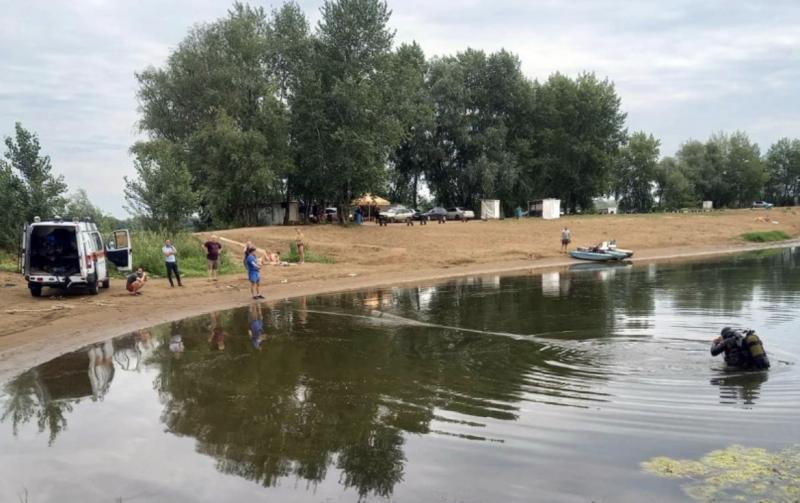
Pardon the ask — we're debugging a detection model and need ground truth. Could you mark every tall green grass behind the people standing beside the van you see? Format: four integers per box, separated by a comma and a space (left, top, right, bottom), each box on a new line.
126, 231, 244, 278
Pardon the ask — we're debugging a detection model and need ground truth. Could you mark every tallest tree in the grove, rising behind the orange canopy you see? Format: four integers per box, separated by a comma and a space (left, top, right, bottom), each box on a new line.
310, 0, 403, 217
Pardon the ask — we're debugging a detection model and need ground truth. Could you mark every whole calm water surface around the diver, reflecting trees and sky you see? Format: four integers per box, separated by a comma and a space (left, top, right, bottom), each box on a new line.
0, 249, 800, 503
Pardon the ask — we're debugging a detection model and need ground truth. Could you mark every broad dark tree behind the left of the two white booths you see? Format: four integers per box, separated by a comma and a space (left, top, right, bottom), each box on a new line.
426, 49, 532, 211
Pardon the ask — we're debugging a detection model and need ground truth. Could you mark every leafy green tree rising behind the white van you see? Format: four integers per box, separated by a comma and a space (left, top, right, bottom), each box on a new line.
5, 122, 67, 221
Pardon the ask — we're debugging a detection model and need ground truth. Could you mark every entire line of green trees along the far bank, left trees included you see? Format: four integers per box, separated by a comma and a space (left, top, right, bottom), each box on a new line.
0, 0, 800, 243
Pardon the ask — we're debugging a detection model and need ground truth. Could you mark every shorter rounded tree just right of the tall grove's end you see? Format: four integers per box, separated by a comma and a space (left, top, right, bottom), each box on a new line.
614, 131, 660, 212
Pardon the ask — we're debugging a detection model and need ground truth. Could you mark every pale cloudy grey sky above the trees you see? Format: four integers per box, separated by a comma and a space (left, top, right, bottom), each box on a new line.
0, 0, 800, 217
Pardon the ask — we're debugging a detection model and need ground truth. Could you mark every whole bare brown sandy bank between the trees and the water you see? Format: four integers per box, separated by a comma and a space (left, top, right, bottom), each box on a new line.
0, 210, 800, 378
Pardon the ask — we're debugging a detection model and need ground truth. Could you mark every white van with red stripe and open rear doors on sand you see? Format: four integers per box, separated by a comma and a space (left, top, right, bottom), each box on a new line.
20, 217, 133, 297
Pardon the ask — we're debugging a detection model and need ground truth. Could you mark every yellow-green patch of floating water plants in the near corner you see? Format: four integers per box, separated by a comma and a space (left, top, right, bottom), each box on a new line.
641, 445, 800, 502
